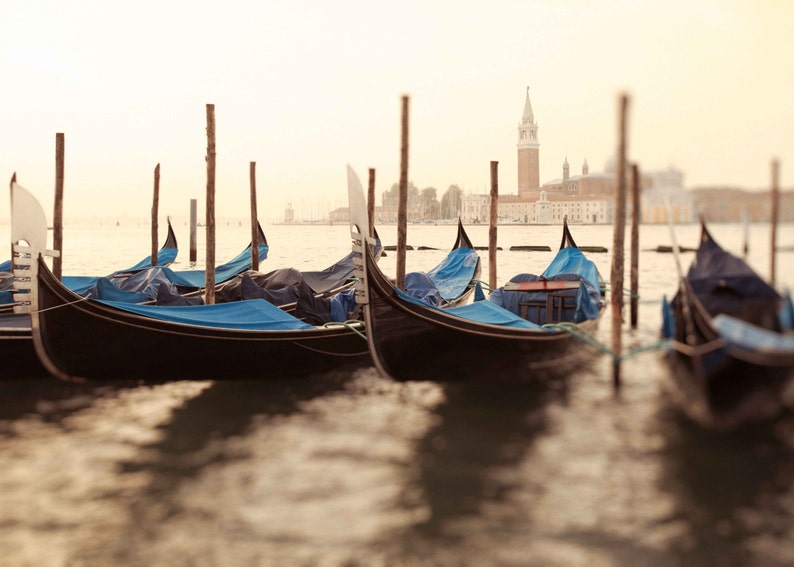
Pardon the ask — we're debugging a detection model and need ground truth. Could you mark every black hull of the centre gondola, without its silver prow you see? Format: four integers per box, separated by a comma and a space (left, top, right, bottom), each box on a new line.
365, 247, 597, 382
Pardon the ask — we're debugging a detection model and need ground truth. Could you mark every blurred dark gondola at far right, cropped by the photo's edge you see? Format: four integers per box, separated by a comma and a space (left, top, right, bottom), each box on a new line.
662, 222, 794, 430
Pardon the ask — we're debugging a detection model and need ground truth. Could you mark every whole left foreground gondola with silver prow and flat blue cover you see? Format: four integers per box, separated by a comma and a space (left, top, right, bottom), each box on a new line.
12, 183, 369, 381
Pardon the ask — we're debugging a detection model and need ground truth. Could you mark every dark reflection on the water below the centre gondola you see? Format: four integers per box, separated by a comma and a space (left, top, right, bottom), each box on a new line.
388, 381, 567, 552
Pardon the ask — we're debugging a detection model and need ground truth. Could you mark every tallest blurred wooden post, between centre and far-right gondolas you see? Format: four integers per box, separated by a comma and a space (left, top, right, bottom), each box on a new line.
610, 94, 629, 387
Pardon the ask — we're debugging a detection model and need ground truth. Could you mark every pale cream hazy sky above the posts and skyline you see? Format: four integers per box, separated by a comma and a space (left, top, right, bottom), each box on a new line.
0, 0, 794, 221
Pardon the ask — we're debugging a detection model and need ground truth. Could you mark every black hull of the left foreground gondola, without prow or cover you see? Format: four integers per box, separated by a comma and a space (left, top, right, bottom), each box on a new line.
33, 259, 369, 380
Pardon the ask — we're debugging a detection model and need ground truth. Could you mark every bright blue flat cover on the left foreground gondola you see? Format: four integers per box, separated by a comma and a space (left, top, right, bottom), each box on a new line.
100, 299, 315, 331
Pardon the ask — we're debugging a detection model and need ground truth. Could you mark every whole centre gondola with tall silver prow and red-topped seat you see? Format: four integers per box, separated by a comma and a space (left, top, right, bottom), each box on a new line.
348, 168, 604, 382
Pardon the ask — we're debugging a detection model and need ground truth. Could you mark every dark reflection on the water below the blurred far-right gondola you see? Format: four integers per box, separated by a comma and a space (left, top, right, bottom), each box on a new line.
659, 406, 794, 566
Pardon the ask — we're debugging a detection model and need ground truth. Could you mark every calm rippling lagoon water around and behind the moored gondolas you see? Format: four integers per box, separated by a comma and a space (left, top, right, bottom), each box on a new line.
0, 223, 794, 566
